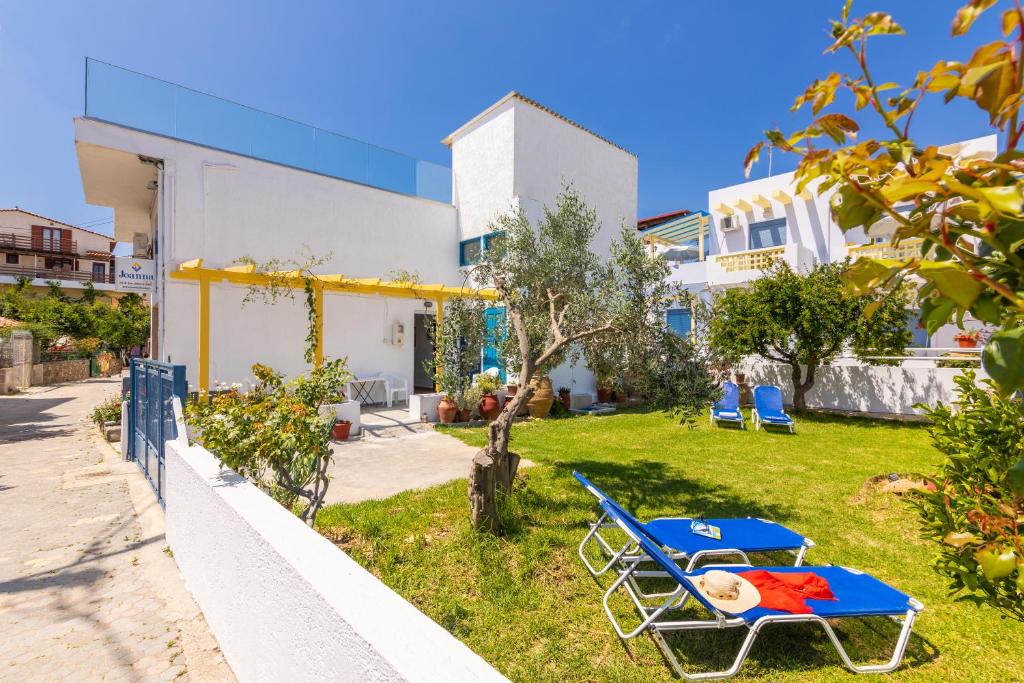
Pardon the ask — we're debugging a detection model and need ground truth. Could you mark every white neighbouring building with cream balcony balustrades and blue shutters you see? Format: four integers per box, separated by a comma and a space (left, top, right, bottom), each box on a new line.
638, 135, 997, 348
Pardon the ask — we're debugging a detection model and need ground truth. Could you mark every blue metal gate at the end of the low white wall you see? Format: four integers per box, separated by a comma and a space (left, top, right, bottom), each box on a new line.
128, 358, 187, 505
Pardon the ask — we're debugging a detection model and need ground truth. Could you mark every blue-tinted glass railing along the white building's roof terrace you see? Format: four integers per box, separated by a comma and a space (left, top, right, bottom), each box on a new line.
85, 59, 452, 204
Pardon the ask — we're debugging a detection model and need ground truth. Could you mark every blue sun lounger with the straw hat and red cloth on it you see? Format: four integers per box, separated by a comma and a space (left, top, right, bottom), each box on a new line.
601, 501, 925, 680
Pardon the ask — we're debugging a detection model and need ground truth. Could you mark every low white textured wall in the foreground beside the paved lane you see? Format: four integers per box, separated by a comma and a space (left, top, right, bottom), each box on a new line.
166, 441, 506, 683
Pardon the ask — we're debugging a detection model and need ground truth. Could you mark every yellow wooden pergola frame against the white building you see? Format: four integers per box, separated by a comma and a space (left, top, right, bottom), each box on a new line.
170, 258, 498, 393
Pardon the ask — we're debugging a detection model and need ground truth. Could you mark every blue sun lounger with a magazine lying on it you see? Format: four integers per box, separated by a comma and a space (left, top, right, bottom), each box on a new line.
572, 472, 814, 581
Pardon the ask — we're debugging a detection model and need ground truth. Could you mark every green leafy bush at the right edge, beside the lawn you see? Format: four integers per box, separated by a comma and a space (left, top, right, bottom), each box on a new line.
914, 371, 1024, 622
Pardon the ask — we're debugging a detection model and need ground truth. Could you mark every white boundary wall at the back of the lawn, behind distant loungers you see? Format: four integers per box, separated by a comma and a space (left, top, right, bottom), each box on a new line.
743, 362, 984, 415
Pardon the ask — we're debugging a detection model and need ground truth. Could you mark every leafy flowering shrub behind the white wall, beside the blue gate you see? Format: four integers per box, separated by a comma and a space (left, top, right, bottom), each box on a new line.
185, 358, 351, 525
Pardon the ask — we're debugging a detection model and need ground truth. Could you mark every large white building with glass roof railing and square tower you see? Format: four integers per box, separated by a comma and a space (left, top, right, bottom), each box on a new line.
75, 60, 637, 392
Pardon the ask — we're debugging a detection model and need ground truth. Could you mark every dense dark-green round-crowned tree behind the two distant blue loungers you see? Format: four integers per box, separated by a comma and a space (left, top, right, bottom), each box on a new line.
708, 261, 911, 410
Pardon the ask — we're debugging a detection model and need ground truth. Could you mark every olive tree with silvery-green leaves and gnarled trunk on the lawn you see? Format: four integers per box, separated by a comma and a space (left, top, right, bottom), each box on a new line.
469, 185, 675, 531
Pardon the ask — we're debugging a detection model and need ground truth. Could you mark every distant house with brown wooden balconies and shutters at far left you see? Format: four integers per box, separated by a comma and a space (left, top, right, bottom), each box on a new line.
0, 207, 117, 292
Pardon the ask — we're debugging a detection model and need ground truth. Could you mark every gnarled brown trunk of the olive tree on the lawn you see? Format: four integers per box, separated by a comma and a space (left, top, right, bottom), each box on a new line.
468, 385, 534, 532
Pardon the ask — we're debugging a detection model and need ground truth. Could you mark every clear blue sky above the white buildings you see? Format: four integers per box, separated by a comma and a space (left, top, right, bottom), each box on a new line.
0, 0, 996, 232
